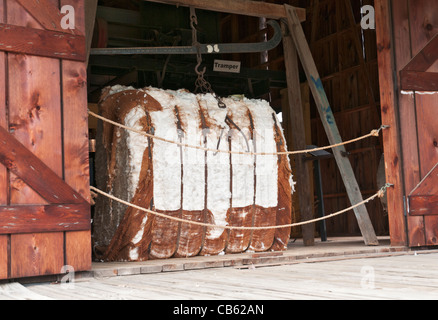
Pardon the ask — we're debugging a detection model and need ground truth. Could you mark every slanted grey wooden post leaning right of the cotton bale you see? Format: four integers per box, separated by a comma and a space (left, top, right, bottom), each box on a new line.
285, 5, 379, 246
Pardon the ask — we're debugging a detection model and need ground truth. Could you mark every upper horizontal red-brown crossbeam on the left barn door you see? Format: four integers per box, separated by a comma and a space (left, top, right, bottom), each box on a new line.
0, 24, 86, 61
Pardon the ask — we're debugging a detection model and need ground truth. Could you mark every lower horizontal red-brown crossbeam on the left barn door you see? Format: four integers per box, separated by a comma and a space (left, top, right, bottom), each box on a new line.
0, 204, 91, 235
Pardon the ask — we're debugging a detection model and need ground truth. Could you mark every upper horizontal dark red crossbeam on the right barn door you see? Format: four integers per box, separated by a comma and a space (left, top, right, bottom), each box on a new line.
400, 70, 438, 91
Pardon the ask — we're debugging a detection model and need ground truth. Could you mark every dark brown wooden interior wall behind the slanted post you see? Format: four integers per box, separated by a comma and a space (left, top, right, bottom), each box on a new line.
222, 0, 388, 236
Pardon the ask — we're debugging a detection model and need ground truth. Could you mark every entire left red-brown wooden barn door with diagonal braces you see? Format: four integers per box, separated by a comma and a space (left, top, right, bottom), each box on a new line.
0, 0, 91, 279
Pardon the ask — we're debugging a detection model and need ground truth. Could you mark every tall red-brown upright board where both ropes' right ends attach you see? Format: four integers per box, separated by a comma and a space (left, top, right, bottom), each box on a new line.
375, 0, 407, 246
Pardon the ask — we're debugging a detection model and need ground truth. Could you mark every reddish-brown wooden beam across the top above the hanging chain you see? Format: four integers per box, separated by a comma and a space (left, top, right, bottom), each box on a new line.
146, 0, 306, 22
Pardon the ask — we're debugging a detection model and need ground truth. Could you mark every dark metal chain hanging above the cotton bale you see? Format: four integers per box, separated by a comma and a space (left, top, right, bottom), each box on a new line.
190, 7, 227, 109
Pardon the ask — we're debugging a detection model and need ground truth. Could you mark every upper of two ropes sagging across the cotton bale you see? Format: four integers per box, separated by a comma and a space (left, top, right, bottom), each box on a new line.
88, 110, 388, 156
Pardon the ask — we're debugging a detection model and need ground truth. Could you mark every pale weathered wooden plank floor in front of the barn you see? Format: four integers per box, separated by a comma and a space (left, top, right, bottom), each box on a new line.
0, 238, 438, 300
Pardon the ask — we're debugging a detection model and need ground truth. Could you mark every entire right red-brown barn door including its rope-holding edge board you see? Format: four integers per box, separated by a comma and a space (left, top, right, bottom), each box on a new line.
376, 0, 438, 247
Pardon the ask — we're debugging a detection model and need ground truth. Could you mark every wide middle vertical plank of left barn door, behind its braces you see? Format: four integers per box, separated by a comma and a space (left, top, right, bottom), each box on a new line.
7, 0, 64, 278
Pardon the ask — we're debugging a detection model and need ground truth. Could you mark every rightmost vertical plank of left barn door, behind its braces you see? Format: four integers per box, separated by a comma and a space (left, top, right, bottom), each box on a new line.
61, 0, 91, 271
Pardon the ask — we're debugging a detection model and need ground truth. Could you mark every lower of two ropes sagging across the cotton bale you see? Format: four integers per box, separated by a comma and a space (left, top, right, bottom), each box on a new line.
90, 183, 392, 230
